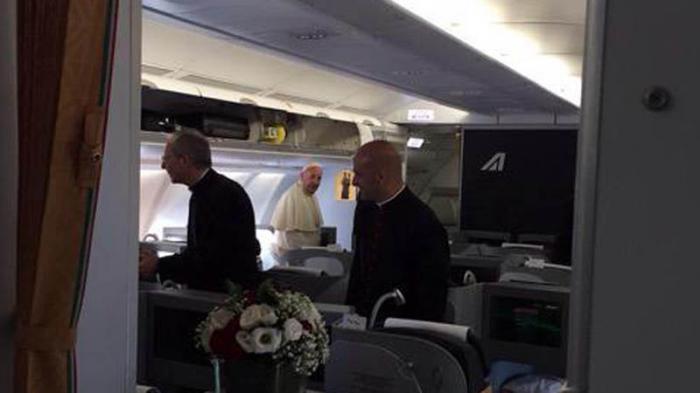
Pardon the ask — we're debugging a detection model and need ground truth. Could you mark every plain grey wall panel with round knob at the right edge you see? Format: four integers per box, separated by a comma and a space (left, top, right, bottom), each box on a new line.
572, 0, 700, 393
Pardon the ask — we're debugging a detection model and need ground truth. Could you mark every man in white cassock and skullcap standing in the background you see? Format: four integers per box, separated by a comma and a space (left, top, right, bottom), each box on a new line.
270, 163, 323, 257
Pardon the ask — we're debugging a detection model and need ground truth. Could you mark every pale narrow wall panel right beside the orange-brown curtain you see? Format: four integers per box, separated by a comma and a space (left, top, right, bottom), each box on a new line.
77, 1, 141, 393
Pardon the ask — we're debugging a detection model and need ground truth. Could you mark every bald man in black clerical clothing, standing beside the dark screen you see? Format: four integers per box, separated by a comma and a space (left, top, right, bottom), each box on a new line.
347, 141, 450, 321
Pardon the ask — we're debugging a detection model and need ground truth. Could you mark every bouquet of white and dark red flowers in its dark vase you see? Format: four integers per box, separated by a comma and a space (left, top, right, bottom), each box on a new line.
195, 280, 329, 393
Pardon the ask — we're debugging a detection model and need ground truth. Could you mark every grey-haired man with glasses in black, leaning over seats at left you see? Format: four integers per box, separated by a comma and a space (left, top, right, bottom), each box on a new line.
139, 131, 260, 291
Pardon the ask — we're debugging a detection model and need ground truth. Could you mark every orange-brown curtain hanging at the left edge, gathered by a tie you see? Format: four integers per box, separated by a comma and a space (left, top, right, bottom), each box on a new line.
14, 0, 117, 393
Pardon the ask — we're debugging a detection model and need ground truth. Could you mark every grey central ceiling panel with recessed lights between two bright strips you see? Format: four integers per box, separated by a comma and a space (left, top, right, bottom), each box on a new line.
144, 0, 577, 113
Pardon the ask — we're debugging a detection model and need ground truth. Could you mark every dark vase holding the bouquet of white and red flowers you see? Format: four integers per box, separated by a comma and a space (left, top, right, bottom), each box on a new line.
223, 358, 306, 393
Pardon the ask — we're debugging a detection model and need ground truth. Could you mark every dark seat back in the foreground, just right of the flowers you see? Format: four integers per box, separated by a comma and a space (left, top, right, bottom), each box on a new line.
325, 319, 486, 393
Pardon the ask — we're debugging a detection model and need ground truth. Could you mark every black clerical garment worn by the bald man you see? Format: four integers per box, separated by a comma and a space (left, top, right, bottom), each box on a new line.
347, 188, 450, 321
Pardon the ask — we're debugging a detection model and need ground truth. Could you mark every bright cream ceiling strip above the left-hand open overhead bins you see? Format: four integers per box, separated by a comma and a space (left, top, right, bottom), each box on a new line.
142, 13, 460, 117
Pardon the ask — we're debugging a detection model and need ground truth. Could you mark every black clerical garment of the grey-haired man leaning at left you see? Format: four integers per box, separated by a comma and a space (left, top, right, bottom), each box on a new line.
158, 169, 260, 291
